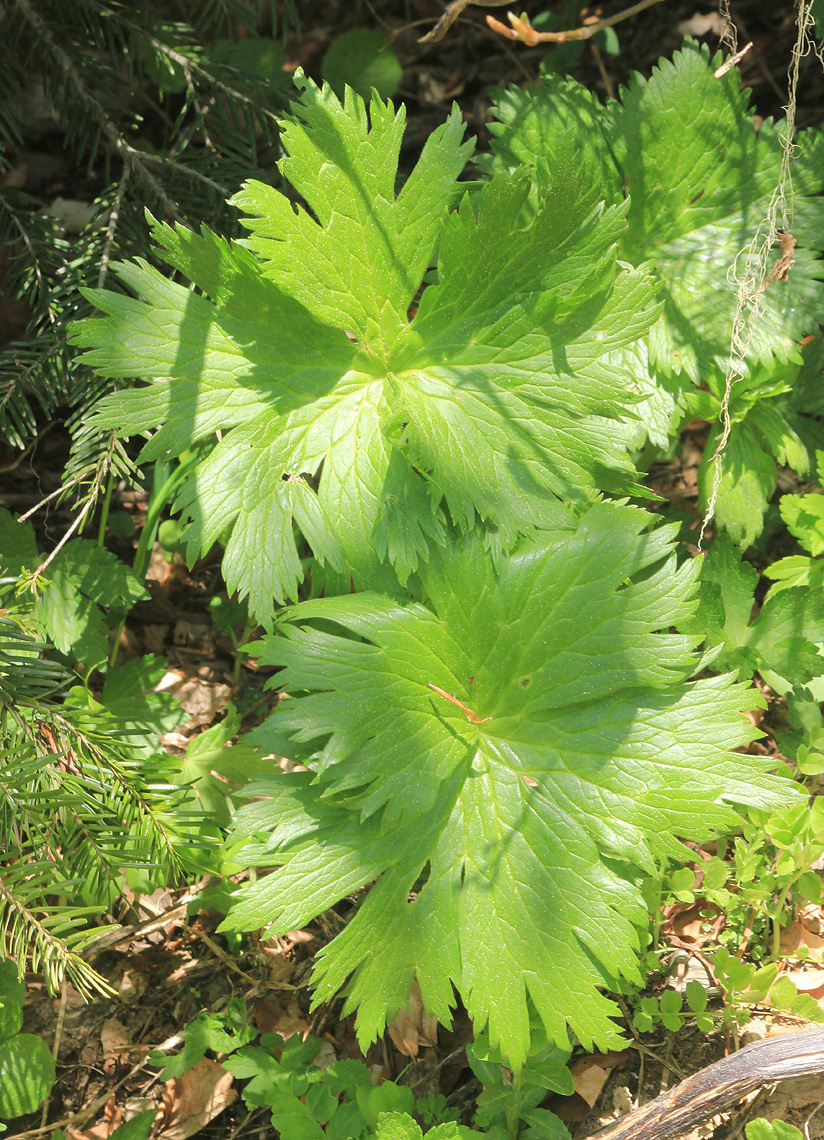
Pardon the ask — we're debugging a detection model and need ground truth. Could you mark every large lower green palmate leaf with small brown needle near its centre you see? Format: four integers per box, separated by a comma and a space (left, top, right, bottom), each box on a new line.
226, 504, 794, 1065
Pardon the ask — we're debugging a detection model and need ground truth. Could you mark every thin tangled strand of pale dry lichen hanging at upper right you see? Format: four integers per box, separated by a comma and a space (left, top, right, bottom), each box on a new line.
699, 0, 814, 551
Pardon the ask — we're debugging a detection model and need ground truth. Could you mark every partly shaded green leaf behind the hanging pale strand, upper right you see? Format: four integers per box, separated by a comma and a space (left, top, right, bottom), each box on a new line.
488, 41, 824, 381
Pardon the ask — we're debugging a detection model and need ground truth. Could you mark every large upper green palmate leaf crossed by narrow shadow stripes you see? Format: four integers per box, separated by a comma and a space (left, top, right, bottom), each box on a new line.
76, 75, 655, 624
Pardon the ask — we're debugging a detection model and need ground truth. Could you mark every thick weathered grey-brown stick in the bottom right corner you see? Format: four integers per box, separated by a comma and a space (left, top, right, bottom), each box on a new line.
589, 1029, 824, 1140
